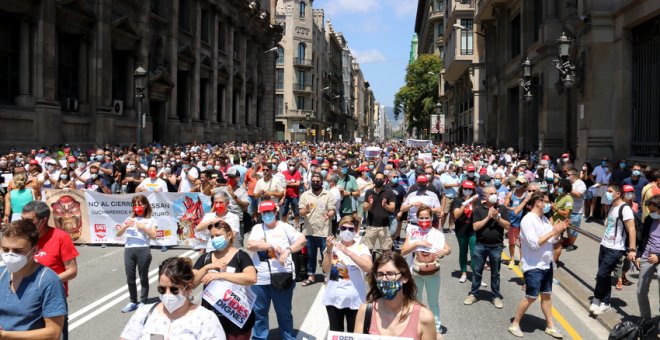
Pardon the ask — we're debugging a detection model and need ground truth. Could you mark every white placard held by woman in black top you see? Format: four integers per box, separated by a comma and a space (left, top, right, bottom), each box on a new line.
202, 280, 257, 328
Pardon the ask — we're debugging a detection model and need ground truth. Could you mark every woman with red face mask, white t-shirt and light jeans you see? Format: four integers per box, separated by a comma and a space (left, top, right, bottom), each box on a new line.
401, 205, 451, 333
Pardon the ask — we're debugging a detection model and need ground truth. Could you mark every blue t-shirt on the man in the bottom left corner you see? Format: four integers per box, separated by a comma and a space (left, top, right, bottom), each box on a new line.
0, 265, 67, 331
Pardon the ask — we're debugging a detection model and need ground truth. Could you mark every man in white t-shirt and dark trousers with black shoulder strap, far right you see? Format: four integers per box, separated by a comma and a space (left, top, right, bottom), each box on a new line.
589, 184, 637, 315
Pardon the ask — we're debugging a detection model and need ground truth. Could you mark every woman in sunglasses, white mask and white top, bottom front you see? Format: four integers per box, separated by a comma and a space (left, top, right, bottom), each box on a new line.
120, 257, 222, 340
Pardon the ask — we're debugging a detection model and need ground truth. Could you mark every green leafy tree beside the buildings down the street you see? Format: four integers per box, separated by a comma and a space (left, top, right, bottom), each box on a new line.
394, 54, 442, 137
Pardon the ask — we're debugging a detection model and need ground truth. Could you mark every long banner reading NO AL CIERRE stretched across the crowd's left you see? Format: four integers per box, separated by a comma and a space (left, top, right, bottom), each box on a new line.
44, 189, 211, 246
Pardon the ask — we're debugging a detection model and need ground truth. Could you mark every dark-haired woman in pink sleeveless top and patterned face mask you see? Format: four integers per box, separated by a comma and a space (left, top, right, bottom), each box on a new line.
354, 251, 436, 340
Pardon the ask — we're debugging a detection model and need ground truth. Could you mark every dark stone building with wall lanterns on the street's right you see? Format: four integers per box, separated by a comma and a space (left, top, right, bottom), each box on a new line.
474, 0, 660, 164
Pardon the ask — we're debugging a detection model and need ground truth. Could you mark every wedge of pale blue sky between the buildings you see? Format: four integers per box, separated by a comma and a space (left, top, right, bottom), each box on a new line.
313, 0, 417, 106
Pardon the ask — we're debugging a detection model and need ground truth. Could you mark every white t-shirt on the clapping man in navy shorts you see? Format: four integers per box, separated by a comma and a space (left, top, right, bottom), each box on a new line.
520, 213, 557, 272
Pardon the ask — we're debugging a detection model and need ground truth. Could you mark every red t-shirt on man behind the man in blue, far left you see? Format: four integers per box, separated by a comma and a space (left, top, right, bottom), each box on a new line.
34, 227, 79, 296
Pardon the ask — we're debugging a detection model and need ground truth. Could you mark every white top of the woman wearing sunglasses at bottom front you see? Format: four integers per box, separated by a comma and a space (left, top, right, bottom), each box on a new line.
121, 304, 222, 340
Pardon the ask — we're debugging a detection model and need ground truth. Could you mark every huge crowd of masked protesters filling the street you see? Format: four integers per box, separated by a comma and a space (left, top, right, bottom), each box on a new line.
0, 142, 660, 339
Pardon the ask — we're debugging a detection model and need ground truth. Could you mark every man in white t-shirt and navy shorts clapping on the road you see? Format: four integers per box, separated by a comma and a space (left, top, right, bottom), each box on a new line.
508, 193, 570, 339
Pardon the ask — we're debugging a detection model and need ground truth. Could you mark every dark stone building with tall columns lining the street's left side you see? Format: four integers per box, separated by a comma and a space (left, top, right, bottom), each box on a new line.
0, 0, 281, 148
